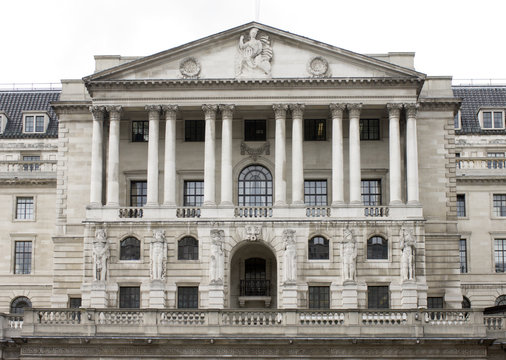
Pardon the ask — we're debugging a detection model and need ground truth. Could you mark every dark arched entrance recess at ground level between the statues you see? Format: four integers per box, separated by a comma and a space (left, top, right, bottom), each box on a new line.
230, 241, 277, 308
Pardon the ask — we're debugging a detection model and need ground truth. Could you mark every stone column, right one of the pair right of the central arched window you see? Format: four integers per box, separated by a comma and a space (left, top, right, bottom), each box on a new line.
290, 104, 305, 205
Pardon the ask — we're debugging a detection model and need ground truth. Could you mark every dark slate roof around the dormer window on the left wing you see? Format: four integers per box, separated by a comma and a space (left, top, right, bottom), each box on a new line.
0, 90, 61, 139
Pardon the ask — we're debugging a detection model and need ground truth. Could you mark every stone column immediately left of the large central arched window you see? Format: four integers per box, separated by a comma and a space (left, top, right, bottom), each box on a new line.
220, 105, 234, 205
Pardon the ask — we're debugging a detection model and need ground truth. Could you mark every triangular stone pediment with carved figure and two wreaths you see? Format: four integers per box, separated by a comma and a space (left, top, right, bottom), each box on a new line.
84, 22, 425, 82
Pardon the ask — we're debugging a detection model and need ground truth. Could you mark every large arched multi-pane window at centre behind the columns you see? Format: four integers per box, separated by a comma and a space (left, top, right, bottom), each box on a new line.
238, 165, 272, 206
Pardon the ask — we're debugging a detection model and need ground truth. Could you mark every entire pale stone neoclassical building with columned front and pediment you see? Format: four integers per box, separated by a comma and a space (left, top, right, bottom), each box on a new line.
0, 23, 506, 359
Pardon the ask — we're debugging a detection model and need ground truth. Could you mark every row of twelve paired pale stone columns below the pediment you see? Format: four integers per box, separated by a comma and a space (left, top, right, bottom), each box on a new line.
90, 103, 419, 207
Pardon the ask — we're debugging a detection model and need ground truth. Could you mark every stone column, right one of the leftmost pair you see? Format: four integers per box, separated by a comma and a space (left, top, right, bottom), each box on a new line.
106, 106, 122, 206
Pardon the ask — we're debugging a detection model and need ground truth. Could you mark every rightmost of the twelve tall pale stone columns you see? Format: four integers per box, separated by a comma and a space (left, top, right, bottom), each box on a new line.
404, 104, 419, 204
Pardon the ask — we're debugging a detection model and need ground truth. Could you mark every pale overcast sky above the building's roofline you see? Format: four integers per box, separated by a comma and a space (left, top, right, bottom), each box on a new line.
0, 0, 506, 83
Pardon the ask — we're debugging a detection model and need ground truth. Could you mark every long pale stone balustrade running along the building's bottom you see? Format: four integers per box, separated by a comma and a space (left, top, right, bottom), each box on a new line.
0, 309, 494, 338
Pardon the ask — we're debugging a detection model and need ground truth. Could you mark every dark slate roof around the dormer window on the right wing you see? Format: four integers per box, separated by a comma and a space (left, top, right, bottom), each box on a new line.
453, 86, 506, 135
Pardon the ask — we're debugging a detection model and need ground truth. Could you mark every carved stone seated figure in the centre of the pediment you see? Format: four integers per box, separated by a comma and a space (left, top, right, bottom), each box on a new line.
236, 28, 272, 77
